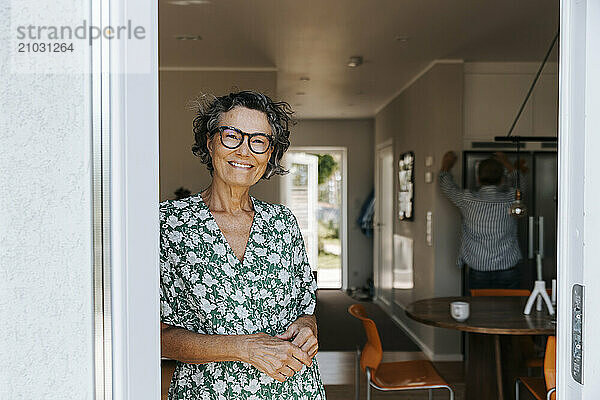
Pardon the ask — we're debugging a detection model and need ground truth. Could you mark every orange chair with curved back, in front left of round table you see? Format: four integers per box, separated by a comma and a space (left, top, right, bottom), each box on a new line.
348, 304, 454, 400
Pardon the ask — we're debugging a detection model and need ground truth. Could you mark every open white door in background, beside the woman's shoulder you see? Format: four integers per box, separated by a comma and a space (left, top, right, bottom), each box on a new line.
281, 152, 319, 271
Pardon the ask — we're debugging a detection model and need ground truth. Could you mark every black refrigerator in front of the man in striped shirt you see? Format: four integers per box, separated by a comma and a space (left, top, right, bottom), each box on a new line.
463, 151, 558, 292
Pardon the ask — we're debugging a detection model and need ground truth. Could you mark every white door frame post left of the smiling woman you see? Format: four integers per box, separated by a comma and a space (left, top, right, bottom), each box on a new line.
96, 0, 161, 400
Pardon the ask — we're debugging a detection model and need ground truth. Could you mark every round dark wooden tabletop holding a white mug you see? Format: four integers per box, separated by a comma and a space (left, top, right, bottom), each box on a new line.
406, 296, 556, 335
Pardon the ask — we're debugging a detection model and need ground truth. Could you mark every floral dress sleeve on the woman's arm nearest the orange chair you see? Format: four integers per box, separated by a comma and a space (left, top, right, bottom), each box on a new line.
286, 208, 317, 317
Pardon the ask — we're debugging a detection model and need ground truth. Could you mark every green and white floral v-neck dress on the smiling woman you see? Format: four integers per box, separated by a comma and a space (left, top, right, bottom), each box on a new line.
160, 193, 325, 400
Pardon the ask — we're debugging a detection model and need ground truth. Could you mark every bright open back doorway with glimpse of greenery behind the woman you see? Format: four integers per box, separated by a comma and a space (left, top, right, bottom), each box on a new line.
280, 147, 347, 289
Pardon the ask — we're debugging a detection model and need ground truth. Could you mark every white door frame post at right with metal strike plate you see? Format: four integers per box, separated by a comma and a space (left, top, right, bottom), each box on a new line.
557, 0, 600, 400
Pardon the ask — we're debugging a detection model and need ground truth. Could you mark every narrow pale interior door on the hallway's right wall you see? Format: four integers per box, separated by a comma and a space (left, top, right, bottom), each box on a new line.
373, 145, 394, 306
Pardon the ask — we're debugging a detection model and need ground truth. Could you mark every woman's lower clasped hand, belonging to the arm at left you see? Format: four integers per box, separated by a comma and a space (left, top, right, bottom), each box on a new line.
240, 333, 312, 382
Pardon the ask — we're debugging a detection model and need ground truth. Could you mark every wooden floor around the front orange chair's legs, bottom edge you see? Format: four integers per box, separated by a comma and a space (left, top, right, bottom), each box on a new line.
162, 351, 465, 400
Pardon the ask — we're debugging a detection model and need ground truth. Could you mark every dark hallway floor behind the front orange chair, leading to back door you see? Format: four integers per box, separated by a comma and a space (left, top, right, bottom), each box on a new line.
315, 290, 420, 351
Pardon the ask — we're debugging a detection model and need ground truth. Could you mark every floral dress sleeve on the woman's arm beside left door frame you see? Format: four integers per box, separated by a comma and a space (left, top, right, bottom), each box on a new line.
159, 202, 183, 327
